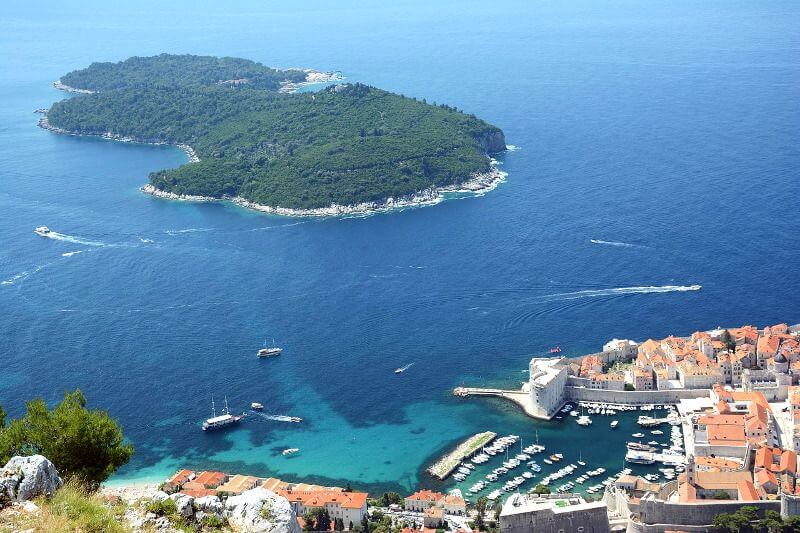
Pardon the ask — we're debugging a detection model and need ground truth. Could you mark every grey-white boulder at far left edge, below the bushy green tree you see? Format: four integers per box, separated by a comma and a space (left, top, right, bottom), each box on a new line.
0, 455, 63, 502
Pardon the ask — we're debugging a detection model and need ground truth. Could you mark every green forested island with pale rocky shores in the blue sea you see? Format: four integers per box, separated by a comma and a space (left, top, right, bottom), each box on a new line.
41, 54, 506, 215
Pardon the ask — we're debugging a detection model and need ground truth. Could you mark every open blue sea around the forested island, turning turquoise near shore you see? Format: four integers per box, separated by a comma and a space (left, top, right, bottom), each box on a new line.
0, 0, 800, 491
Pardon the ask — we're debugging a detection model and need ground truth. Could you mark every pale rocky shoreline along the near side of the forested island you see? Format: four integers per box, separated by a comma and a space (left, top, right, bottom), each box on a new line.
141, 160, 508, 217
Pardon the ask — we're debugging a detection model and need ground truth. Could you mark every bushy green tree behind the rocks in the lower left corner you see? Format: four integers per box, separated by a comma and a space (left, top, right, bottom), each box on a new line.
0, 389, 133, 489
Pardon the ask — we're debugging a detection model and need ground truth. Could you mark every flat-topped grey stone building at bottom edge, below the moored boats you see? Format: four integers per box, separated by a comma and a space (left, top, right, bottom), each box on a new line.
500, 494, 609, 533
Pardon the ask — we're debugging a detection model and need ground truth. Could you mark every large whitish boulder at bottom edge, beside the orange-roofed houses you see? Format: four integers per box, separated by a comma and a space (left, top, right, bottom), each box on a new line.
225, 487, 300, 533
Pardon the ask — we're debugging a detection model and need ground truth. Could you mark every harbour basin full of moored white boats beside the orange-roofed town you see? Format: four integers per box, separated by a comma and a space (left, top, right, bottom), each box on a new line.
432, 402, 684, 502
